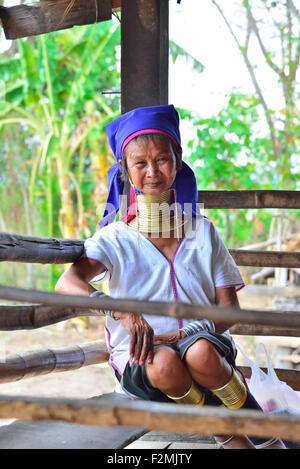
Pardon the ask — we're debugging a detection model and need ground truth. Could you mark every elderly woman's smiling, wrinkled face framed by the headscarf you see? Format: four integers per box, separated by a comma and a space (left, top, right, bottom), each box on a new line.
120, 137, 176, 195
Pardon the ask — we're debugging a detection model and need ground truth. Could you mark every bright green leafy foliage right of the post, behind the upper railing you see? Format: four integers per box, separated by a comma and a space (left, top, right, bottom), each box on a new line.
180, 92, 300, 248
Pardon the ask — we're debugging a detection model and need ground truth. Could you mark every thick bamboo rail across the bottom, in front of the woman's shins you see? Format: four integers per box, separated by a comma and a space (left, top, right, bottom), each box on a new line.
0, 396, 300, 441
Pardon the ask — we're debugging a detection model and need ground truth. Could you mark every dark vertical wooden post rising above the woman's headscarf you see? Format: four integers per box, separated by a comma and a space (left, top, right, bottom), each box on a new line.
121, 0, 169, 113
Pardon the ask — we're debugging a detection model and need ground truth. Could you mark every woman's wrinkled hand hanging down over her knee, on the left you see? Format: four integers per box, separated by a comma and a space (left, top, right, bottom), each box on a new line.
114, 312, 154, 366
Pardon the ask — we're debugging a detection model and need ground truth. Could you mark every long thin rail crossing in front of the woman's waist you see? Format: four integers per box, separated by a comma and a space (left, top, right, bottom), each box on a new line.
0, 286, 300, 329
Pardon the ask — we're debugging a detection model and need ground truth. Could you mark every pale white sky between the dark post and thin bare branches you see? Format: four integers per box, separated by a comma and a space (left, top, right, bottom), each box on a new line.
169, 0, 253, 117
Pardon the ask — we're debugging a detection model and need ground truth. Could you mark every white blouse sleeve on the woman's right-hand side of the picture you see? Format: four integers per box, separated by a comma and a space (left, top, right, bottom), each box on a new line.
211, 223, 245, 291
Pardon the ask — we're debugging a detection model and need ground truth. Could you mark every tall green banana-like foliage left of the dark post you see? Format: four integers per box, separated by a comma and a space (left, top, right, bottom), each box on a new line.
0, 22, 120, 288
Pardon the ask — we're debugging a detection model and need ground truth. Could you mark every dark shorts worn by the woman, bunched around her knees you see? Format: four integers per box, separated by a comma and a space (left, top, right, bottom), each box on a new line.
115, 331, 235, 405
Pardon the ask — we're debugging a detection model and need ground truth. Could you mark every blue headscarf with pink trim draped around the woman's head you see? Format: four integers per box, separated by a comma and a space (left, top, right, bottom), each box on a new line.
98, 104, 199, 228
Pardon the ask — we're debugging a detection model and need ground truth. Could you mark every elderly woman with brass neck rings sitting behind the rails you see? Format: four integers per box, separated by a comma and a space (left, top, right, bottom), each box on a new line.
56, 105, 284, 449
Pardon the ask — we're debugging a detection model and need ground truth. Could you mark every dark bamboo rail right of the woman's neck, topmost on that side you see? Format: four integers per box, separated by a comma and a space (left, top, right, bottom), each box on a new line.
198, 190, 300, 209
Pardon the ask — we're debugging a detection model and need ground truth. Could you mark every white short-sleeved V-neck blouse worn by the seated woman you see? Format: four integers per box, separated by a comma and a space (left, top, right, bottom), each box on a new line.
85, 216, 245, 375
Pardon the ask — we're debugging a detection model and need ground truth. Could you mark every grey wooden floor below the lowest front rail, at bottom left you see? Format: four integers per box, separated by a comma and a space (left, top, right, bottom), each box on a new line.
0, 420, 216, 450
